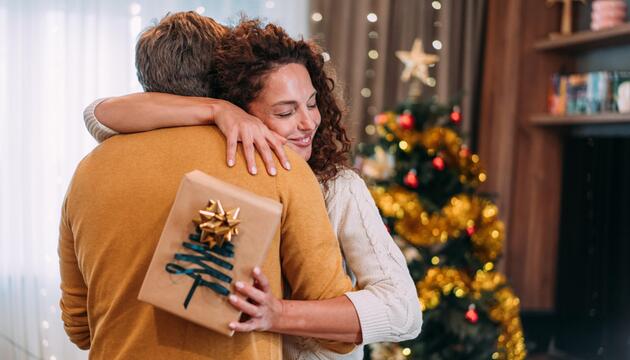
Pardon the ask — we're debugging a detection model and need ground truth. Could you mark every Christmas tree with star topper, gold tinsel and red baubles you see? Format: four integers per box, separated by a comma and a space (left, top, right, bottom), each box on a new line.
357, 40, 526, 360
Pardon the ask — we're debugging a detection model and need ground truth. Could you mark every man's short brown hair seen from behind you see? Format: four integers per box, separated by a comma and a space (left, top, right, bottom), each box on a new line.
136, 11, 228, 96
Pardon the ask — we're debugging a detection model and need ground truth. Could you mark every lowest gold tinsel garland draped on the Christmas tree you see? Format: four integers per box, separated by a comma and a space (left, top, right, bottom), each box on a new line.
417, 267, 527, 360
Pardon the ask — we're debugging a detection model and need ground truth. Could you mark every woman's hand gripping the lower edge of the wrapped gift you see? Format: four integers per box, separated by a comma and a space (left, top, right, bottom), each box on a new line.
228, 267, 283, 332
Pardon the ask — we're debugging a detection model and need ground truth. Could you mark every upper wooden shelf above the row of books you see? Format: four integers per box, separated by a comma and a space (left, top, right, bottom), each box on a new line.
534, 23, 630, 52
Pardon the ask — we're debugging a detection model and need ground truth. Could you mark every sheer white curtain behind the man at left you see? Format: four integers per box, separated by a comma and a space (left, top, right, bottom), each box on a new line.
0, 0, 308, 360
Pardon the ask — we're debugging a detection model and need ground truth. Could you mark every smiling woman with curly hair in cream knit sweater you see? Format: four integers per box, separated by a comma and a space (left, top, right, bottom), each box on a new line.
85, 21, 422, 359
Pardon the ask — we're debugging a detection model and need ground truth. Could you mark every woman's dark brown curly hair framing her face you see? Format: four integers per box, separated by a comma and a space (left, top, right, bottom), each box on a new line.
209, 20, 350, 186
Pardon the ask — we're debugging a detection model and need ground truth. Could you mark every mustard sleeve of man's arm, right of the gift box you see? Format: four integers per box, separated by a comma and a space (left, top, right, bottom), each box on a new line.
276, 152, 356, 354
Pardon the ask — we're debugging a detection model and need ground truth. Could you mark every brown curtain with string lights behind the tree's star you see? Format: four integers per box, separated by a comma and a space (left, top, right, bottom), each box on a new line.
311, 0, 486, 146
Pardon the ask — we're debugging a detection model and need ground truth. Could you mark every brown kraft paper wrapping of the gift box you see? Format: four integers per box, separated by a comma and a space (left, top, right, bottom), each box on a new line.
138, 170, 282, 336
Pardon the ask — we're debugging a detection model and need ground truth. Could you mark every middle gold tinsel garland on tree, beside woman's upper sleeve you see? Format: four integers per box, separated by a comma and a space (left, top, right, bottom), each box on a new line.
370, 186, 505, 262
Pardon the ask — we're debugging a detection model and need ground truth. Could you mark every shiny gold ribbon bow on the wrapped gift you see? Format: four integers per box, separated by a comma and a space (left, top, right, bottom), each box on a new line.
193, 200, 241, 247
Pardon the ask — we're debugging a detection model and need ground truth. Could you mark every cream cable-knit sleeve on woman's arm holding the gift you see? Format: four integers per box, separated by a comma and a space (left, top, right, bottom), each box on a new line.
327, 170, 422, 344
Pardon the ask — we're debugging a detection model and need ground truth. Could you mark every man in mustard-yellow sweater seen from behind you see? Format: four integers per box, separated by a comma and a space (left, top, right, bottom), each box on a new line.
59, 12, 352, 359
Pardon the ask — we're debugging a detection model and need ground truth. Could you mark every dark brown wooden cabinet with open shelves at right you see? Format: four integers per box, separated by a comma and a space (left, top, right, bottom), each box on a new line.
478, 0, 630, 310
